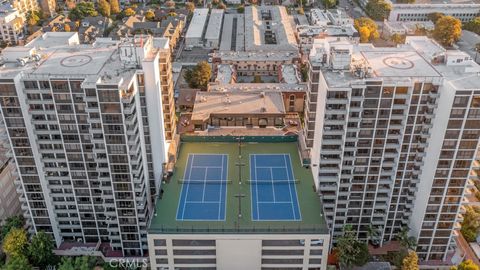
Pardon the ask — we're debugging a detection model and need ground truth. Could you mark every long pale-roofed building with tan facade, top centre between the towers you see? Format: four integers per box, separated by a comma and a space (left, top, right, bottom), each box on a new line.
212, 6, 300, 77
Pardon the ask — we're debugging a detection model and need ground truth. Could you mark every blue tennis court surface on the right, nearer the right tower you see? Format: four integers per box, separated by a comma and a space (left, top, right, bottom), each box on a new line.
250, 154, 302, 221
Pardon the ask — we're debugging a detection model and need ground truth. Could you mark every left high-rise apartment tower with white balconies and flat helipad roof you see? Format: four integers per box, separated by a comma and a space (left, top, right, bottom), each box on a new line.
0, 33, 172, 256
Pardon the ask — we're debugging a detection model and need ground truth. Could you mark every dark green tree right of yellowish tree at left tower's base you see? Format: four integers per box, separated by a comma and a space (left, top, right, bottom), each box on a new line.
28, 231, 55, 268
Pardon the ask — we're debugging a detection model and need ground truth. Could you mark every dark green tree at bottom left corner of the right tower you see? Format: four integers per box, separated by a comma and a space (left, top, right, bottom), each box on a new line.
335, 225, 370, 269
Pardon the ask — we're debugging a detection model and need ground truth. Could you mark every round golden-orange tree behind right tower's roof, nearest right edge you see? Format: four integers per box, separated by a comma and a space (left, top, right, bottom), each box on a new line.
433, 16, 462, 47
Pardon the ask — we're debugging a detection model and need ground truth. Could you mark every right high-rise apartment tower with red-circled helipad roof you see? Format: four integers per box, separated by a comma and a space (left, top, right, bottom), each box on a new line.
304, 37, 480, 260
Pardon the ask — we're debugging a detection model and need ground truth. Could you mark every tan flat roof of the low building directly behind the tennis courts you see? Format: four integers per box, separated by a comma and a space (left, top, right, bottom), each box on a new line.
192, 92, 286, 121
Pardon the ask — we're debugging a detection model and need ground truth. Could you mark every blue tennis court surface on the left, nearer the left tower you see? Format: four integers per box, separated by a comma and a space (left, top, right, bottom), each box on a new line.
177, 154, 228, 220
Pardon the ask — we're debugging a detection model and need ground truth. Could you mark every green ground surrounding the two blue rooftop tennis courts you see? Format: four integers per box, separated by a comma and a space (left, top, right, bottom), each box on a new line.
149, 142, 328, 234
